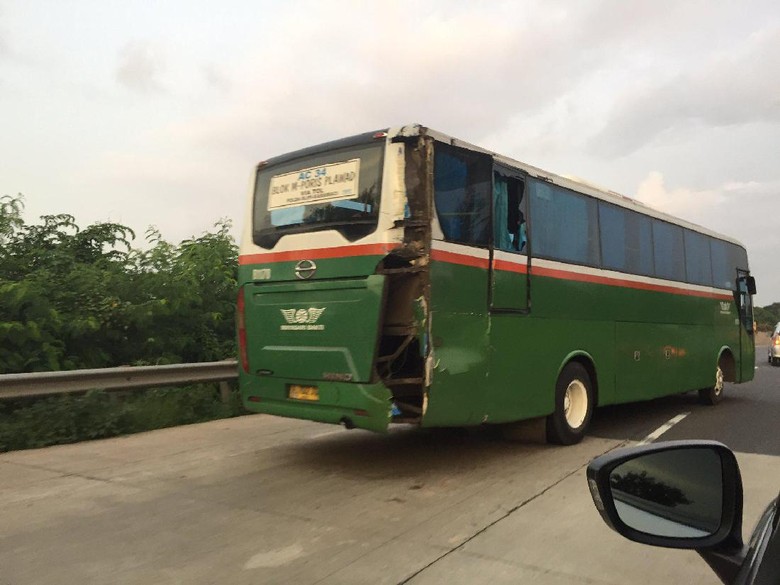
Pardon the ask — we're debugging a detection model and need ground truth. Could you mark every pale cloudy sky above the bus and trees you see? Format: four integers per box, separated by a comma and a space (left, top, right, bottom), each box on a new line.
0, 0, 780, 306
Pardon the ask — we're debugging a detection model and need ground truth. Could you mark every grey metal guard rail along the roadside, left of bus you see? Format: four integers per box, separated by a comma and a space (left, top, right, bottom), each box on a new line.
0, 360, 238, 401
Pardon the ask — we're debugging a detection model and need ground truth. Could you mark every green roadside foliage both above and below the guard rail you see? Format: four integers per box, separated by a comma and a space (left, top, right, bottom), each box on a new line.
0, 195, 242, 452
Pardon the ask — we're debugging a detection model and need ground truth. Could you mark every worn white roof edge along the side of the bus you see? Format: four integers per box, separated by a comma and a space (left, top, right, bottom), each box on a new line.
394, 124, 745, 248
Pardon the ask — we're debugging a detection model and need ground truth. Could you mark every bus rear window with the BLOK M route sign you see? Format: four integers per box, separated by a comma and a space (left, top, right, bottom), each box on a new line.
252, 143, 384, 249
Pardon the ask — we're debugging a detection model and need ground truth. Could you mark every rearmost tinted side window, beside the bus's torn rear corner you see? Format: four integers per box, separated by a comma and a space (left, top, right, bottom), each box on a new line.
433, 142, 491, 246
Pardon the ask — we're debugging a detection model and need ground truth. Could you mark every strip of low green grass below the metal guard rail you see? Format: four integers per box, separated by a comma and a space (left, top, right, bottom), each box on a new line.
0, 384, 246, 452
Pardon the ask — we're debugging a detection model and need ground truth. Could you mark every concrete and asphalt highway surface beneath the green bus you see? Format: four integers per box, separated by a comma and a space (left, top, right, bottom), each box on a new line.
0, 346, 780, 585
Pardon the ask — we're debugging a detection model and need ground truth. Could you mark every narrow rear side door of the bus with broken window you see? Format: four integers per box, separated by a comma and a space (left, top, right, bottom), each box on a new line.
489, 166, 530, 314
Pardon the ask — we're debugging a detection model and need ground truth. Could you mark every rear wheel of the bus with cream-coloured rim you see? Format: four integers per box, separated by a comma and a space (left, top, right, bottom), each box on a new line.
547, 362, 593, 445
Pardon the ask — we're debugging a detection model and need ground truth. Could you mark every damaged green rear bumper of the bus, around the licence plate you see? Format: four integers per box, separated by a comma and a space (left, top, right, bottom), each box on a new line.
241, 376, 392, 433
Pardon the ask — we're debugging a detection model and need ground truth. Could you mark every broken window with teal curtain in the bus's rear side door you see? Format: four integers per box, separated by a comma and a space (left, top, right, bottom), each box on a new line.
493, 173, 528, 252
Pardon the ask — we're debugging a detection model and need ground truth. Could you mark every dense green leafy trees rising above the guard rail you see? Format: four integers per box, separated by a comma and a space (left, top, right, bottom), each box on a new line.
0, 195, 238, 373
